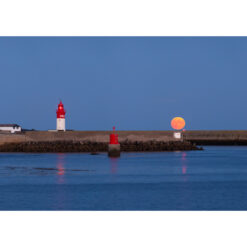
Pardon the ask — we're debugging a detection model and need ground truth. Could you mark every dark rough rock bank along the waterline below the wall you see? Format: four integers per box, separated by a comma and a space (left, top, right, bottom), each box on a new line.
0, 141, 203, 154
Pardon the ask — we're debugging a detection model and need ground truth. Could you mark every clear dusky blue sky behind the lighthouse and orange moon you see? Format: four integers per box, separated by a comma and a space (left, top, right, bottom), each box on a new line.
0, 37, 247, 130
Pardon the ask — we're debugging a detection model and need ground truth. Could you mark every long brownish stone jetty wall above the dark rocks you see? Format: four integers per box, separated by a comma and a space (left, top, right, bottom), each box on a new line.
0, 130, 247, 145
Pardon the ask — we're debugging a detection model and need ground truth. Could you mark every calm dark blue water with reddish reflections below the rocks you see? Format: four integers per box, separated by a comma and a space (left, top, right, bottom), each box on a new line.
0, 147, 247, 210
